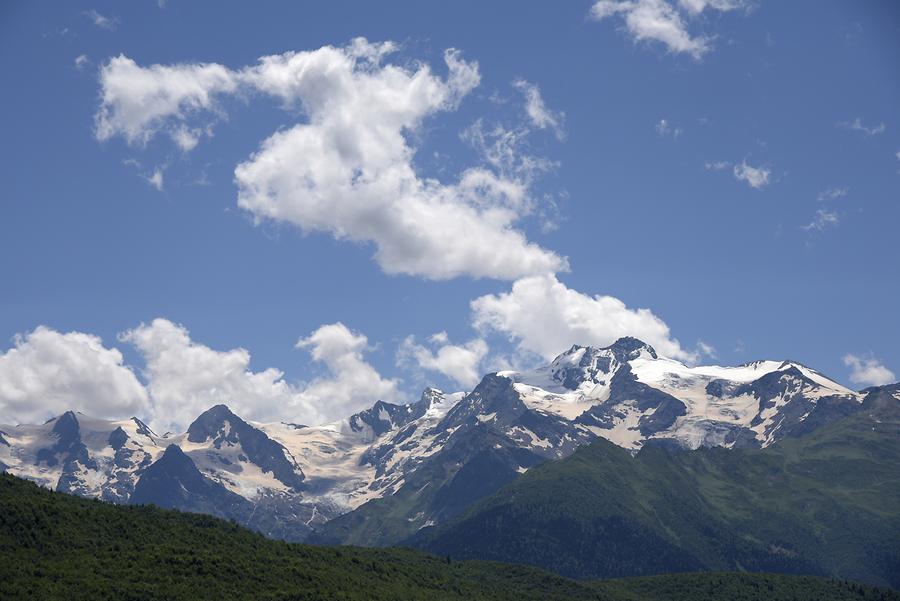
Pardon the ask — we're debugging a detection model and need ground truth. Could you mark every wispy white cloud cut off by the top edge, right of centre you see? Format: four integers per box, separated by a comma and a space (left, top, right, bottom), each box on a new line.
590, 0, 747, 59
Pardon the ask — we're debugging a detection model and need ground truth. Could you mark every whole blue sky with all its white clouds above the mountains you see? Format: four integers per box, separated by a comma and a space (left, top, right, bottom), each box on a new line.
0, 0, 900, 427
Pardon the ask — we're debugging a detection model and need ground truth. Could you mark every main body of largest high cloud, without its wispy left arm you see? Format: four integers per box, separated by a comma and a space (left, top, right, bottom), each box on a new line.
235, 46, 565, 279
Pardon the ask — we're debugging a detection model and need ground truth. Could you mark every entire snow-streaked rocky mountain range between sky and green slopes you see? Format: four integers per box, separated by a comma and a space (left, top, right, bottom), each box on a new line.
0, 338, 862, 543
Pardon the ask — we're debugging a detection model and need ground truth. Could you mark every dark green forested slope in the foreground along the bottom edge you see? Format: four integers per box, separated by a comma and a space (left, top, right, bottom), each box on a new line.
0, 475, 900, 601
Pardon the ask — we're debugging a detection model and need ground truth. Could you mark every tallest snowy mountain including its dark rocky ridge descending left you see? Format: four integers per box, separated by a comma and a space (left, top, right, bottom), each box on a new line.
313, 338, 862, 545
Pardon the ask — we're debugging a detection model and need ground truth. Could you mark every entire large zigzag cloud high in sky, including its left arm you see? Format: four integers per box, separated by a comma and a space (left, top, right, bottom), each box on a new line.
96, 39, 567, 279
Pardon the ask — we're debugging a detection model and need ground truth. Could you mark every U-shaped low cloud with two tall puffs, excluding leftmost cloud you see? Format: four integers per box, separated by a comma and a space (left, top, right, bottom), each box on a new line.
121, 319, 399, 431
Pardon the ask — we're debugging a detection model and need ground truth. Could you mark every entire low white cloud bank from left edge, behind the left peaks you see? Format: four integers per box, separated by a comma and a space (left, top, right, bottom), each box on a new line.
0, 318, 403, 432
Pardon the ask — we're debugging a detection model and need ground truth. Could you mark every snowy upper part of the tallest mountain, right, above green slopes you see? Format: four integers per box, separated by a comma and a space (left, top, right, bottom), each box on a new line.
498, 338, 862, 449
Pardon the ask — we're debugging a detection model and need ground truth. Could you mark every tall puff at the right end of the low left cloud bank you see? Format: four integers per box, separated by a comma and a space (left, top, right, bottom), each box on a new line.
297, 322, 403, 420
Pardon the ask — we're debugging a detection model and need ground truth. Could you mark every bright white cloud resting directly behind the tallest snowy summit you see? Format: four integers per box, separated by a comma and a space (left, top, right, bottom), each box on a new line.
471, 275, 697, 362
